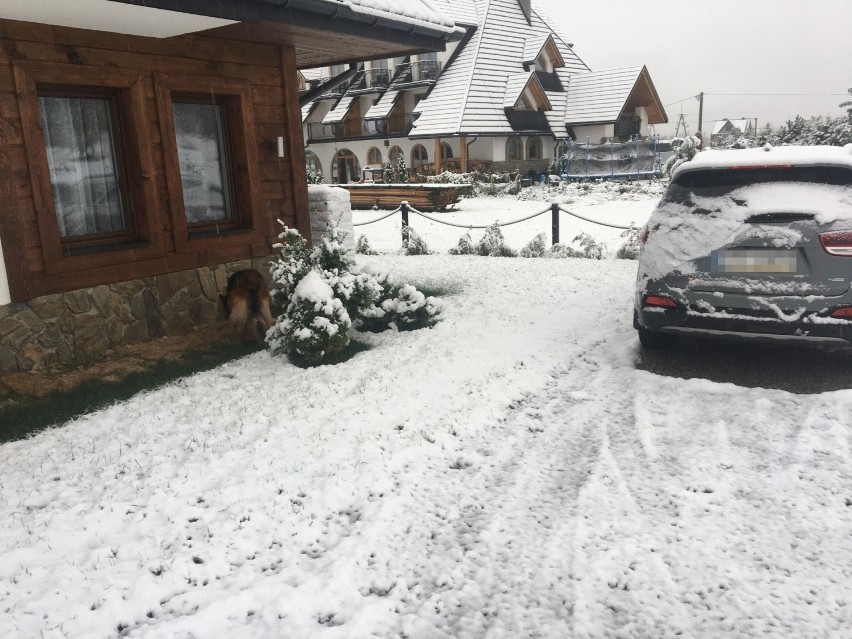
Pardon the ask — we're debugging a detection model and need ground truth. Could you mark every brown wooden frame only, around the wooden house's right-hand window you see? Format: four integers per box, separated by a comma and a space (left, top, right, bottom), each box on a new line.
154, 73, 266, 253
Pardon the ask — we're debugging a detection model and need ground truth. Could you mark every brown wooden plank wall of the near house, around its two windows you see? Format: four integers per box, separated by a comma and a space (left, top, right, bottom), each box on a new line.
0, 20, 310, 301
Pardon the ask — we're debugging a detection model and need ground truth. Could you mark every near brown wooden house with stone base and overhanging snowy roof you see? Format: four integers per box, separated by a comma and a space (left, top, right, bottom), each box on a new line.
0, 0, 458, 372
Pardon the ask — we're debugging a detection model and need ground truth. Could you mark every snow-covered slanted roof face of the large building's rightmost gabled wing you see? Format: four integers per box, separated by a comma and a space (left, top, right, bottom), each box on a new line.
565, 67, 643, 126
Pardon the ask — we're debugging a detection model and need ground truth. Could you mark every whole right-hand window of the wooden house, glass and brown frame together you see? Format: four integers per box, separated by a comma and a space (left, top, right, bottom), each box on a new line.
154, 73, 264, 252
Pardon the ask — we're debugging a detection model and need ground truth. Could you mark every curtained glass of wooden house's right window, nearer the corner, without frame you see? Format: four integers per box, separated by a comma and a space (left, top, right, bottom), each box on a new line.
174, 102, 233, 224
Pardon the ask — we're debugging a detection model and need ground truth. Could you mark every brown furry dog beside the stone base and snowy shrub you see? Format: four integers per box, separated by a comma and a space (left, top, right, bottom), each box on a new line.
219, 269, 273, 343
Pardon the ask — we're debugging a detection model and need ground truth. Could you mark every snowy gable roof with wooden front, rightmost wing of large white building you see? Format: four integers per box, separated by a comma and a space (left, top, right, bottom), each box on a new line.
565, 66, 668, 126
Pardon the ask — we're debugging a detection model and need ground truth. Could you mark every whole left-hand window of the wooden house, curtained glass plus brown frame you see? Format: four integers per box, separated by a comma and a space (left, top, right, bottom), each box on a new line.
12, 61, 164, 278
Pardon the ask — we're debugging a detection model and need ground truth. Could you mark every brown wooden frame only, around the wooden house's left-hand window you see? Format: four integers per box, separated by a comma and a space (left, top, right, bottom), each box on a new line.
13, 62, 164, 274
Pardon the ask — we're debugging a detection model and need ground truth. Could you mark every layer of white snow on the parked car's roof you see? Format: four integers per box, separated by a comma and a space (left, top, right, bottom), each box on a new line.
672, 144, 852, 177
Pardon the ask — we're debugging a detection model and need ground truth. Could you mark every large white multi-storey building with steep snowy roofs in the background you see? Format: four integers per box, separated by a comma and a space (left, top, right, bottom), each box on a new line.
302, 0, 668, 182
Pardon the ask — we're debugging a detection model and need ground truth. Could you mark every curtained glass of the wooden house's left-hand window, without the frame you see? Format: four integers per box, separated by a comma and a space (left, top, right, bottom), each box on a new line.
39, 97, 127, 237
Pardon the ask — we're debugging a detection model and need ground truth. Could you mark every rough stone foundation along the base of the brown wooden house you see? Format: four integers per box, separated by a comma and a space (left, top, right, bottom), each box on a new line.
0, 255, 272, 374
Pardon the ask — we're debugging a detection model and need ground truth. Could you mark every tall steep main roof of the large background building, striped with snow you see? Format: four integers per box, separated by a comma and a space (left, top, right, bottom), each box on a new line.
411, 0, 589, 137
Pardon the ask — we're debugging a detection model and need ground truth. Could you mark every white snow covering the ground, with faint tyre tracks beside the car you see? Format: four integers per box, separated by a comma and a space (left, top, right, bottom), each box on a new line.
0, 190, 852, 639
